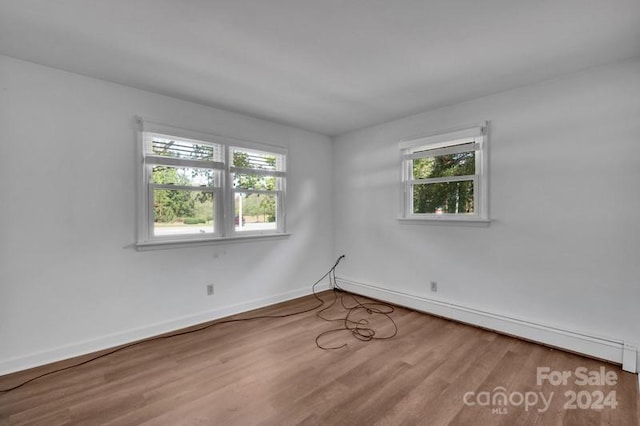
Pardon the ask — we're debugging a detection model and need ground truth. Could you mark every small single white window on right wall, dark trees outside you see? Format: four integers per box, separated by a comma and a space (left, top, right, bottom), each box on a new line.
399, 123, 489, 222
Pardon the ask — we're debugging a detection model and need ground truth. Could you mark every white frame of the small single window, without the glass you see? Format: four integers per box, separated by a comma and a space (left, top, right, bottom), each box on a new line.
398, 122, 490, 224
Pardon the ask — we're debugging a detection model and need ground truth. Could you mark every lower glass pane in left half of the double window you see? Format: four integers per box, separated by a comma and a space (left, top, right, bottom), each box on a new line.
153, 189, 215, 236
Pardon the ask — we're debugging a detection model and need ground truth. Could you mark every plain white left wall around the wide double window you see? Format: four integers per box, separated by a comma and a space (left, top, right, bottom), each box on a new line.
0, 56, 332, 374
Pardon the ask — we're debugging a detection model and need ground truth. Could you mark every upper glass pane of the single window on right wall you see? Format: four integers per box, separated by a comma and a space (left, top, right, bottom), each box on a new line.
413, 151, 476, 179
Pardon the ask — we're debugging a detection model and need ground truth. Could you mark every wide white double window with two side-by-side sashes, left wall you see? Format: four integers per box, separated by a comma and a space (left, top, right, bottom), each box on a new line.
137, 119, 287, 248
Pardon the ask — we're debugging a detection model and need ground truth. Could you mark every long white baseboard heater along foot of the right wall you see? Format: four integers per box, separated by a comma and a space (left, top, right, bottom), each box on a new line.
336, 278, 638, 373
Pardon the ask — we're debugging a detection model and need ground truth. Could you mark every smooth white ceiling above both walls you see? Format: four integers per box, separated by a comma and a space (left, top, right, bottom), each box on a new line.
0, 0, 640, 136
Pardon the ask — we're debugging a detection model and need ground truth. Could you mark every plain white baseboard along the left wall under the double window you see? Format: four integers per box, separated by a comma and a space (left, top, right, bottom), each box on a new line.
0, 285, 328, 375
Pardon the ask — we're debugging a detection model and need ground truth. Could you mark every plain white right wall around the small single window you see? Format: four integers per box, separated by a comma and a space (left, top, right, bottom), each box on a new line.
333, 59, 640, 362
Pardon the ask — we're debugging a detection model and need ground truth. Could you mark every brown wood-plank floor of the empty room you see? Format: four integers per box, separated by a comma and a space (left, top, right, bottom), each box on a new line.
0, 292, 639, 426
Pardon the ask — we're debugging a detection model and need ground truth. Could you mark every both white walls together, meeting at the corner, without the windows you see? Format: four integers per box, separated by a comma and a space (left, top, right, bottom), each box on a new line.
0, 56, 640, 374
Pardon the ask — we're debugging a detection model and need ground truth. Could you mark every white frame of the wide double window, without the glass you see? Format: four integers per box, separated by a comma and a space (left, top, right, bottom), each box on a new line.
136, 117, 289, 250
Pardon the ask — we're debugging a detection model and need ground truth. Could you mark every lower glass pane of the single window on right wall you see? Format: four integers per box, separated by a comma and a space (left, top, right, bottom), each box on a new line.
413, 181, 474, 214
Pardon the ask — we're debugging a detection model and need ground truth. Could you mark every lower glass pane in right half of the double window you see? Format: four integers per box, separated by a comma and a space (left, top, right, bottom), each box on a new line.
235, 192, 277, 231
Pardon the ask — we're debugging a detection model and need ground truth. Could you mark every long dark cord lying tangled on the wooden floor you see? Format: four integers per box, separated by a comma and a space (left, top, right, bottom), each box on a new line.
0, 255, 397, 393
